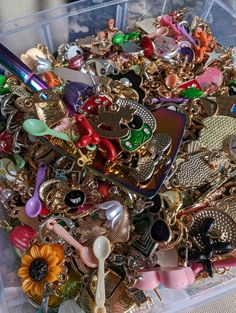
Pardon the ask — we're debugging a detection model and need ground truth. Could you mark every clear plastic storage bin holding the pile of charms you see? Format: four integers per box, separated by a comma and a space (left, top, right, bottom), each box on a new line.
0, 0, 236, 313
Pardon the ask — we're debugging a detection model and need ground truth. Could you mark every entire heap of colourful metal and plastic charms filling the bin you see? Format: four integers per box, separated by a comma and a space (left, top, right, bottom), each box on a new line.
0, 10, 236, 313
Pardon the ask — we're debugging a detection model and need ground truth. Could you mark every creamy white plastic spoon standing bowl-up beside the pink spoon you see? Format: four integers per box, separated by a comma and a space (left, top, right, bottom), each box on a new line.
93, 236, 111, 313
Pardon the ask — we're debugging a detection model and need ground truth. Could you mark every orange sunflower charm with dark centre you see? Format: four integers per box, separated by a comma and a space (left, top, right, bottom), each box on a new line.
18, 244, 64, 297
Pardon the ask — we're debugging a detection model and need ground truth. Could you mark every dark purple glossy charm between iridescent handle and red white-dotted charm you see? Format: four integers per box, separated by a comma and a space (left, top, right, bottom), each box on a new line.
65, 82, 94, 116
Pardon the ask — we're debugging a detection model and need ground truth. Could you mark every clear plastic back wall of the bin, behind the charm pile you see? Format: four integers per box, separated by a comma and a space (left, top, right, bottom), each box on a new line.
0, 0, 236, 55
